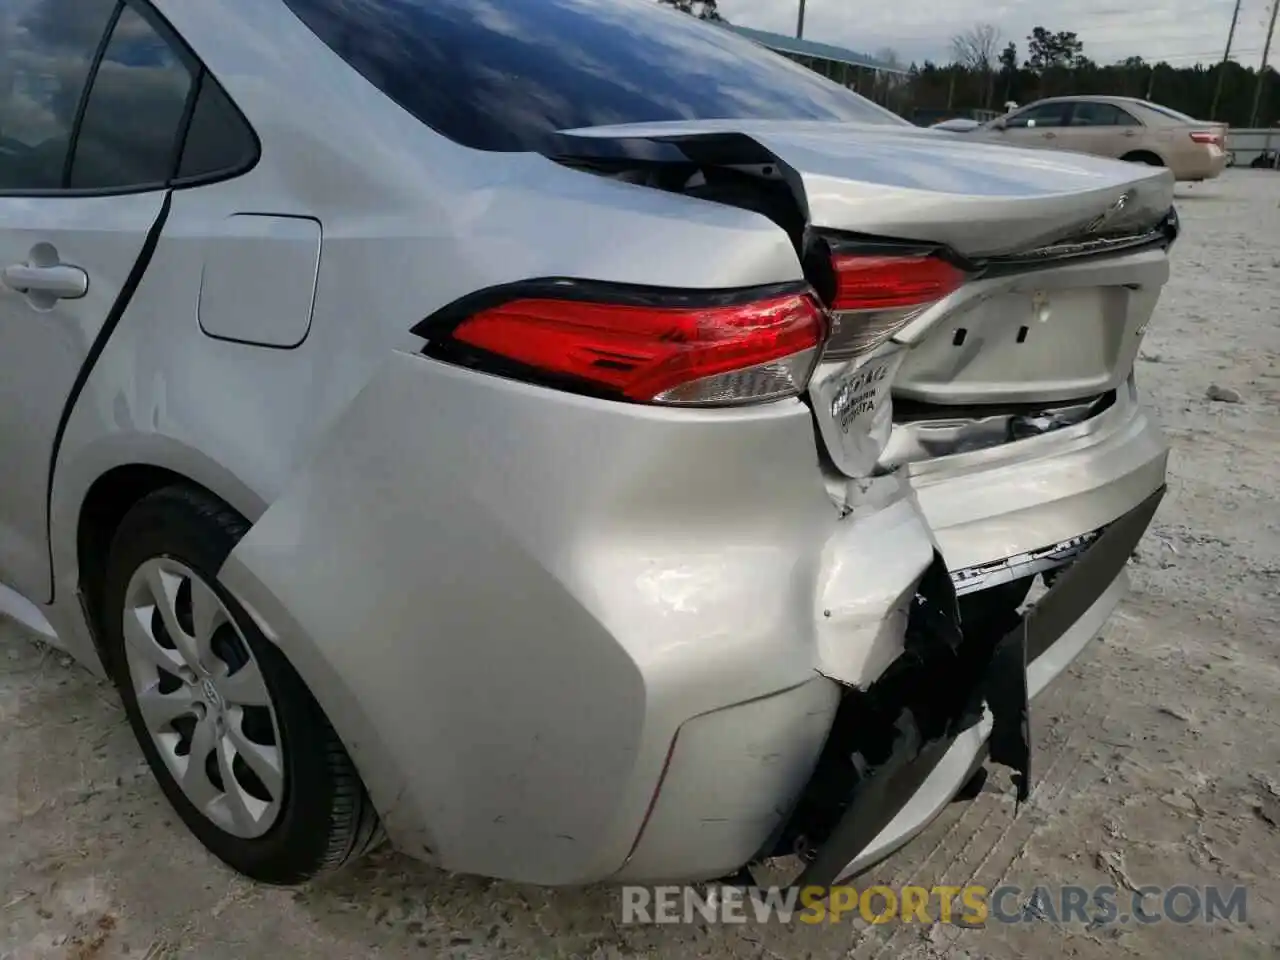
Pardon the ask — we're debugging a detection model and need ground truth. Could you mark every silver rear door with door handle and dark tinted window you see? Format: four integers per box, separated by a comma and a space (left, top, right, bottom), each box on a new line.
0, 0, 195, 602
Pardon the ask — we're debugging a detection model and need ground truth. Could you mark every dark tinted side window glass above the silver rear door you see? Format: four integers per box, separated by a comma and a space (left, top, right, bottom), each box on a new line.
0, 0, 259, 195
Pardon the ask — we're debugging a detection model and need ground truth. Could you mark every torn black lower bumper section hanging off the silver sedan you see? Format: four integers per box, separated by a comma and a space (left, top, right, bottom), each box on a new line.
769, 488, 1165, 887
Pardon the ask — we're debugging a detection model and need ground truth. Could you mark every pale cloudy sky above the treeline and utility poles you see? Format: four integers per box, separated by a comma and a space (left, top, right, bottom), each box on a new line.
719, 0, 1280, 67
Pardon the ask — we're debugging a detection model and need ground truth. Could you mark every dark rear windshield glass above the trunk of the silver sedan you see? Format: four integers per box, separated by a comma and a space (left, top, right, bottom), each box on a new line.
285, 0, 906, 151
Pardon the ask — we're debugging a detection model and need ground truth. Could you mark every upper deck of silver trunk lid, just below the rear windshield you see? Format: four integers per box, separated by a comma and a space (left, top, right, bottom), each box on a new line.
555, 120, 1174, 257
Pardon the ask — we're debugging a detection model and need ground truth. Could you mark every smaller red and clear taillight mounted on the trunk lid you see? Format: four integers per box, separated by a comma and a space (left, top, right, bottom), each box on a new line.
824, 252, 968, 360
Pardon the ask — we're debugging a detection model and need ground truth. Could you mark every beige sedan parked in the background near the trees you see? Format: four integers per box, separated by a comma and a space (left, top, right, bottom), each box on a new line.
964, 96, 1226, 180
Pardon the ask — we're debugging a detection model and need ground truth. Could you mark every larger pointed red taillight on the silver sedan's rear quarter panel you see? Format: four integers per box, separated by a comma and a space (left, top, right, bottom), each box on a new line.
452, 293, 827, 404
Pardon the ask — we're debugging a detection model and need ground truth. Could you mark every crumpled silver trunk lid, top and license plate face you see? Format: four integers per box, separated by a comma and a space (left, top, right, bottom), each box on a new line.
564, 120, 1174, 477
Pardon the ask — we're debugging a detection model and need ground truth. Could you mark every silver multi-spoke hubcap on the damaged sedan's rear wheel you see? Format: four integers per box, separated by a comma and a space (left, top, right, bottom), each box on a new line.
124, 558, 284, 838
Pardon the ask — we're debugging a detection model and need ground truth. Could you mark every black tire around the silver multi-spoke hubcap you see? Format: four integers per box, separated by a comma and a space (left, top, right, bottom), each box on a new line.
101, 486, 381, 884
